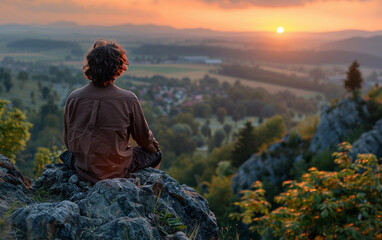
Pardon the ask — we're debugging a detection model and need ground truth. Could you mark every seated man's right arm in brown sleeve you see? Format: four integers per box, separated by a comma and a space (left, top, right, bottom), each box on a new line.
130, 95, 159, 152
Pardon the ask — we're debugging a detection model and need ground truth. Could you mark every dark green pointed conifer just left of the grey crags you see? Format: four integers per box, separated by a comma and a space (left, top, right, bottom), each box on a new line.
232, 122, 257, 167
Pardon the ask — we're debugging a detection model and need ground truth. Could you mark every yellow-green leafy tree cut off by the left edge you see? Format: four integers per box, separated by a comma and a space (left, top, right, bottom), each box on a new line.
0, 100, 32, 163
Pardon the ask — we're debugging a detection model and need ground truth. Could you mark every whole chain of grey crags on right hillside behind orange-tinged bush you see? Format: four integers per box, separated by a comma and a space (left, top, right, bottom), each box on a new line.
232, 99, 382, 193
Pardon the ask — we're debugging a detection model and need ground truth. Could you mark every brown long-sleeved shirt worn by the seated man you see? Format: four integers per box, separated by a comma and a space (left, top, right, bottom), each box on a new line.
64, 83, 158, 183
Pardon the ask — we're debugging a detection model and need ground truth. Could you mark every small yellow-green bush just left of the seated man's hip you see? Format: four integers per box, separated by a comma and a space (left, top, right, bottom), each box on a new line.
33, 146, 64, 178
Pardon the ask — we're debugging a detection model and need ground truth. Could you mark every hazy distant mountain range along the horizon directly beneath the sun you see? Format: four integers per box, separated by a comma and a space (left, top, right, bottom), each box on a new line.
0, 22, 382, 51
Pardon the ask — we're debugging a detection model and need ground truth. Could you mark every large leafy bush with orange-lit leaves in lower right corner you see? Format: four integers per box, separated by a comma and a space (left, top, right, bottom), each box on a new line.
231, 143, 382, 239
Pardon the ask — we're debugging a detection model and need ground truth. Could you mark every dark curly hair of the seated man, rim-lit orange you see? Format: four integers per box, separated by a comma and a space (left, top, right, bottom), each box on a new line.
82, 39, 129, 87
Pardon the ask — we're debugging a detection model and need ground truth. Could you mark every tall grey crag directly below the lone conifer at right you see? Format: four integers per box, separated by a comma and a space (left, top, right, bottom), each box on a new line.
309, 99, 369, 153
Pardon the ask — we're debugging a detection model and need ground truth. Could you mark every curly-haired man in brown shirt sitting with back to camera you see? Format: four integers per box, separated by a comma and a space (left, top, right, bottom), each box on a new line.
61, 40, 162, 183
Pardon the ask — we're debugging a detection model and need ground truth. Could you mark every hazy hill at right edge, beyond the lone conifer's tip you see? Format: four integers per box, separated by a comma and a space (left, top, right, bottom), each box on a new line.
320, 33, 382, 57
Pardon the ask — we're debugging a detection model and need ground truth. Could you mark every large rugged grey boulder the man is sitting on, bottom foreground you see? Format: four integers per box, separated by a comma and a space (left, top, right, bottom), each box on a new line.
78, 168, 218, 239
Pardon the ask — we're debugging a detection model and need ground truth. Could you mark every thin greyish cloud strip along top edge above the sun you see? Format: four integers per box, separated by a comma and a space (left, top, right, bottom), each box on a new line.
202, 0, 368, 8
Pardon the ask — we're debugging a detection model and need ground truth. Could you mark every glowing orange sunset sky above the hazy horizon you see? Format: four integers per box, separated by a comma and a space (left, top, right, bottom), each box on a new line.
0, 0, 382, 32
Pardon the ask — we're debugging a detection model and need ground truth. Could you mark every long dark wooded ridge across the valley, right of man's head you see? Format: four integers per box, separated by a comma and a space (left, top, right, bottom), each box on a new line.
133, 44, 382, 68
